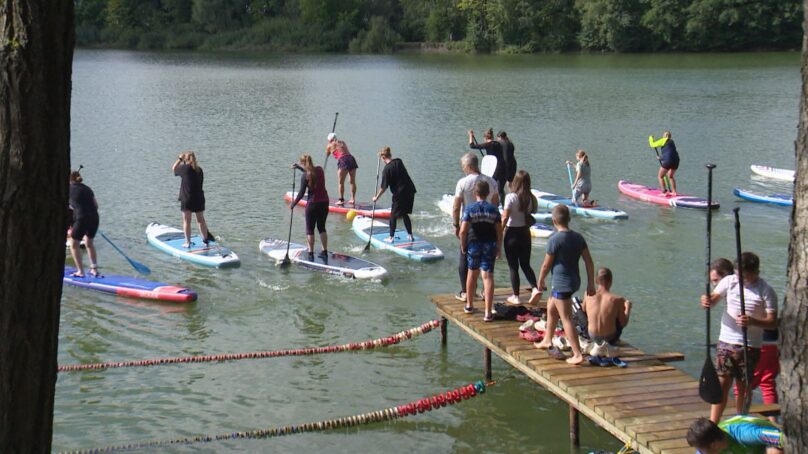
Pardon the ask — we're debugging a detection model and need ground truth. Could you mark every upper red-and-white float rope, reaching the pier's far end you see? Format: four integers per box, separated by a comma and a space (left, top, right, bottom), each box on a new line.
57, 320, 440, 372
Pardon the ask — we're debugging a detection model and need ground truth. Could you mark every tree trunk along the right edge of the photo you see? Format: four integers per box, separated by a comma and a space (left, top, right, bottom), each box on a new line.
777, 0, 808, 453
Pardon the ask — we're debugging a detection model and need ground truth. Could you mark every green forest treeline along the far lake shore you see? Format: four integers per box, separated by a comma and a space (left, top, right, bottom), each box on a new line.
75, 0, 803, 53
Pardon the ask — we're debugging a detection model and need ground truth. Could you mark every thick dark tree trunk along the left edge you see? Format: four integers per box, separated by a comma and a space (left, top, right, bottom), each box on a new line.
0, 0, 74, 453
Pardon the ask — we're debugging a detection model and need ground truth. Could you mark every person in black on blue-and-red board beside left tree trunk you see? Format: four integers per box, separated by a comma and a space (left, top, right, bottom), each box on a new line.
69, 170, 99, 277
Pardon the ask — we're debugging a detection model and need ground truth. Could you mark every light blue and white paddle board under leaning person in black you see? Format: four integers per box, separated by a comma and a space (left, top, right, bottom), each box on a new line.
352, 216, 443, 262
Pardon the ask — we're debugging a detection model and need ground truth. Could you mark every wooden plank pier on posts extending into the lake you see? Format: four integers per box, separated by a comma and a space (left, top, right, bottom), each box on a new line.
432, 289, 778, 454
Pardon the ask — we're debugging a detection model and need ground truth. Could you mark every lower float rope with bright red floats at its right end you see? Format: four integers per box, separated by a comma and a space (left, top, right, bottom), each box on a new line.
60, 381, 497, 454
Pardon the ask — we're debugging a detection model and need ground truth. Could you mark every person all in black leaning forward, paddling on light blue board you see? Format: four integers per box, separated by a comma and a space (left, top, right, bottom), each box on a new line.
373, 147, 416, 243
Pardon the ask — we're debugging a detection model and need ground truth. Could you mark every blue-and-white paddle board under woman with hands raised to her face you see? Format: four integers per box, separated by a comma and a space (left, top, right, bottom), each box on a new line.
146, 222, 241, 267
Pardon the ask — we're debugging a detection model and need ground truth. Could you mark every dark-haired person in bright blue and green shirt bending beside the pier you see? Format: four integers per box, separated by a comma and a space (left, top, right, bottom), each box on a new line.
687, 416, 783, 454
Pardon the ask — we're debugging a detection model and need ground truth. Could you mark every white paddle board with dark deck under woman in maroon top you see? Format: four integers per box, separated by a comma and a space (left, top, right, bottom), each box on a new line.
258, 238, 387, 279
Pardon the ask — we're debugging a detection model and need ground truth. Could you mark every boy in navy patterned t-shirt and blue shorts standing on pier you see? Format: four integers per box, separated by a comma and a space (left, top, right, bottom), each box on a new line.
460, 181, 502, 322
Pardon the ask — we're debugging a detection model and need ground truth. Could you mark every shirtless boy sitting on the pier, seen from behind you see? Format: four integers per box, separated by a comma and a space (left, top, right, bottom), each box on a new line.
583, 267, 631, 344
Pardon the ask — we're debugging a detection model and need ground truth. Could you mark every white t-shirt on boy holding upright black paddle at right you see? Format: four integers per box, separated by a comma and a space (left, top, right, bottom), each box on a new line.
713, 274, 777, 348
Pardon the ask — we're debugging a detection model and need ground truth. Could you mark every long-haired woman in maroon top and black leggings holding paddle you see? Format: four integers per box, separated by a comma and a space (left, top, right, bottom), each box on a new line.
289, 154, 328, 261
